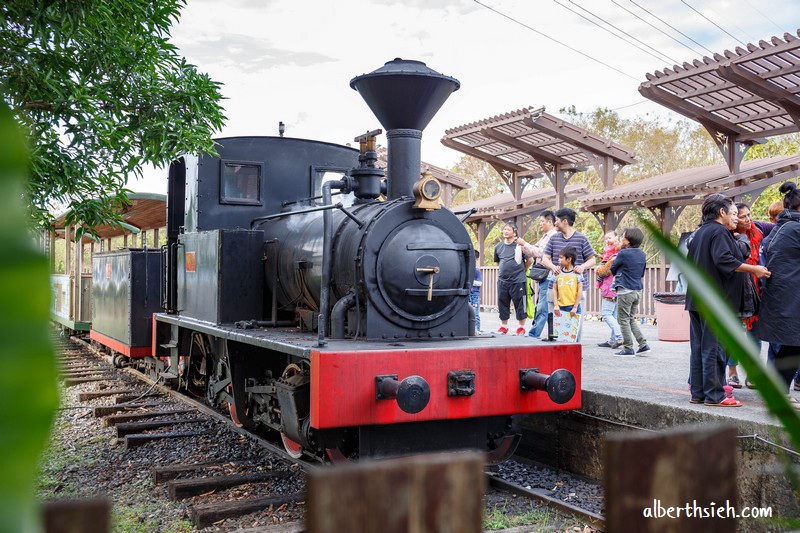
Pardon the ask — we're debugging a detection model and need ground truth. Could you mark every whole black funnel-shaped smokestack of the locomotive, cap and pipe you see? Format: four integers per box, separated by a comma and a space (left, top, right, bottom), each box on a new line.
350, 58, 461, 198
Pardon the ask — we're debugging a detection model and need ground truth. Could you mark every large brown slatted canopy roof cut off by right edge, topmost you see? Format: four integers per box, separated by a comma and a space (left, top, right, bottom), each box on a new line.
639, 30, 800, 142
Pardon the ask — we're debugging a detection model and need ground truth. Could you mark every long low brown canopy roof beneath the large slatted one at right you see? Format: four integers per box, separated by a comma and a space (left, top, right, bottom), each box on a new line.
581, 155, 800, 212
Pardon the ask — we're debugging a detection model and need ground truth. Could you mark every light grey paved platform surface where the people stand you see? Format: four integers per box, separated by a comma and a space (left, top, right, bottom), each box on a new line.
481, 311, 800, 426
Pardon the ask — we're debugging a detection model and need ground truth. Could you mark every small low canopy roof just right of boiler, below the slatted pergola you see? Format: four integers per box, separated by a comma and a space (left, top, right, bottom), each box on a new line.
458, 184, 588, 264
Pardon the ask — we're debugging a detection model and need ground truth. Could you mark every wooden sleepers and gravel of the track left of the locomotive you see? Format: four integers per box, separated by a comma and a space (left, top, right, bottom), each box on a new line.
50, 332, 306, 530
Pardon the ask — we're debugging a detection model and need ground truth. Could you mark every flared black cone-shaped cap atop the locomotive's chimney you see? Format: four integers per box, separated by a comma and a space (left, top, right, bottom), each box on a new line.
350, 57, 461, 131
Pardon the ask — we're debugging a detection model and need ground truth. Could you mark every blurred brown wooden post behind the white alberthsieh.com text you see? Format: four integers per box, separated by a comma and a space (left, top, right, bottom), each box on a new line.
604, 425, 738, 533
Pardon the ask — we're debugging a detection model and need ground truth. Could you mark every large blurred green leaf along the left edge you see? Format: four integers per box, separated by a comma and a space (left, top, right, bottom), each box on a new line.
0, 102, 58, 532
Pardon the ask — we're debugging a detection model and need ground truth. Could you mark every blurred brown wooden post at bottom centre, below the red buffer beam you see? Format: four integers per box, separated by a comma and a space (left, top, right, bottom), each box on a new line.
306, 452, 486, 533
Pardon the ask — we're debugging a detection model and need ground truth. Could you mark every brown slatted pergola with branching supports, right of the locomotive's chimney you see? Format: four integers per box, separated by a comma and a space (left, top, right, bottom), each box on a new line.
442, 107, 635, 239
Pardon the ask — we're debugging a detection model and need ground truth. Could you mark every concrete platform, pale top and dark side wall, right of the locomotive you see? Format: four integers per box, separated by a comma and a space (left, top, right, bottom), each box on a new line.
481, 312, 800, 516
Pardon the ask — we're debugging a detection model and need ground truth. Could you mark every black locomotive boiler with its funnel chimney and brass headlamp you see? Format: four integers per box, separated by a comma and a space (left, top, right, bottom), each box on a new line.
254, 60, 474, 342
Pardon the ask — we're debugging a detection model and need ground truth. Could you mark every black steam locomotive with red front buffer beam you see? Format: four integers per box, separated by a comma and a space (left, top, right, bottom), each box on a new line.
92, 59, 581, 461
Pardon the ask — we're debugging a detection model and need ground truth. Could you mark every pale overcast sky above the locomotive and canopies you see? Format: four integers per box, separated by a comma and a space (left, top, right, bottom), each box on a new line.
129, 0, 800, 193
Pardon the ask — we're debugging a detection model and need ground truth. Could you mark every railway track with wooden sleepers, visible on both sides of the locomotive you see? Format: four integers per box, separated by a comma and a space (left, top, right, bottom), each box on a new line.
53, 332, 605, 531
